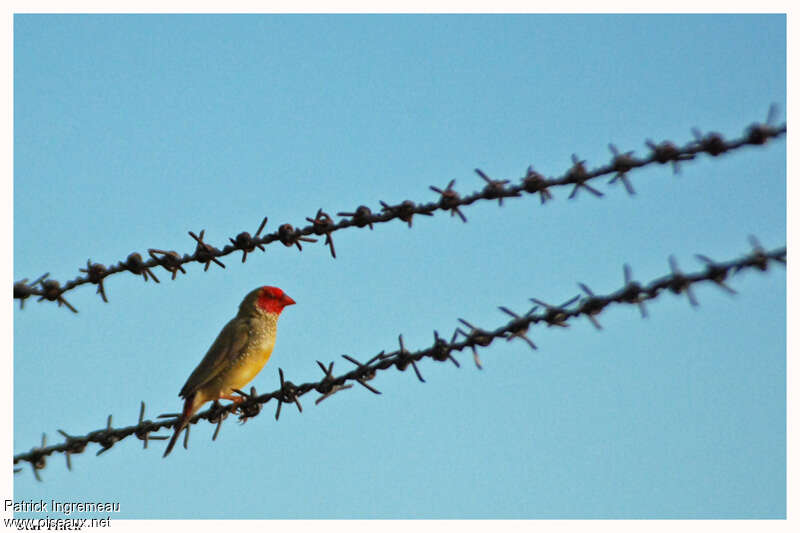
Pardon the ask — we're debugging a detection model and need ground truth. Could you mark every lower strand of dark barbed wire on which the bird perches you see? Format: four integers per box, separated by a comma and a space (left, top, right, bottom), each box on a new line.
14, 237, 786, 480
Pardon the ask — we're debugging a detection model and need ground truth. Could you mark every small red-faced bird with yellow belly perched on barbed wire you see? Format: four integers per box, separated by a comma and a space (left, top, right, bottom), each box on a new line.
164, 286, 295, 457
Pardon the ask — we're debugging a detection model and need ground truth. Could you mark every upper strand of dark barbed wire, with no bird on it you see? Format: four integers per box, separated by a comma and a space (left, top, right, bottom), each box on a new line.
14, 110, 786, 313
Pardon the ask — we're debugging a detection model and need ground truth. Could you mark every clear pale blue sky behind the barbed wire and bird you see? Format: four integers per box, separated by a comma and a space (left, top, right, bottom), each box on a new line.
13, 15, 786, 518
